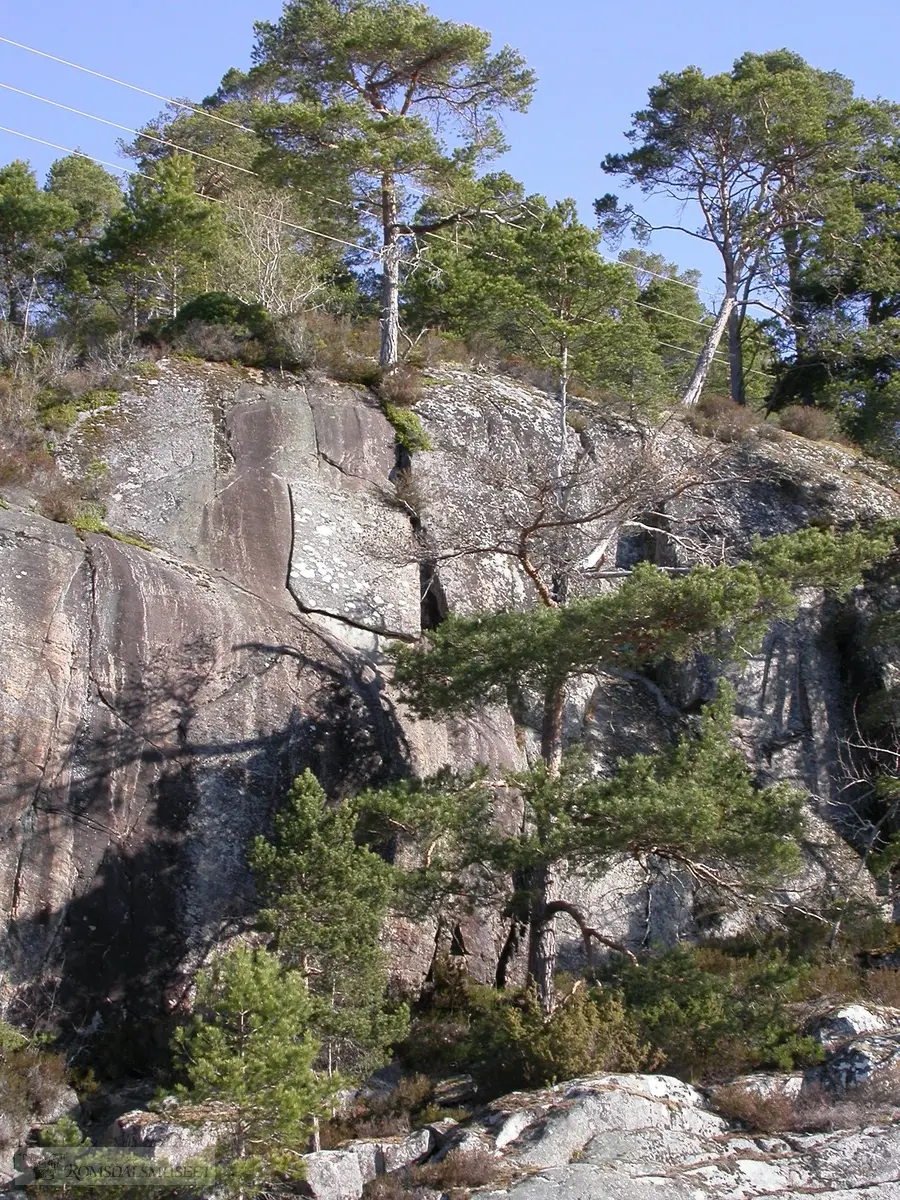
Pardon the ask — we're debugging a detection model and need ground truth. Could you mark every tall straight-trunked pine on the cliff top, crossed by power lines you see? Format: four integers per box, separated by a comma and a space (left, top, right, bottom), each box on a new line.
225, 0, 534, 367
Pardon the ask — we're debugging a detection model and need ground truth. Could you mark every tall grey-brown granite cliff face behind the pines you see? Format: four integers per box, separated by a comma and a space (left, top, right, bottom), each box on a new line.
0, 364, 900, 1031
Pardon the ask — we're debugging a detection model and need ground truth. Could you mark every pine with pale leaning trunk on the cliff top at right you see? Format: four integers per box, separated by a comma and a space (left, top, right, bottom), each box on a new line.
607, 50, 866, 404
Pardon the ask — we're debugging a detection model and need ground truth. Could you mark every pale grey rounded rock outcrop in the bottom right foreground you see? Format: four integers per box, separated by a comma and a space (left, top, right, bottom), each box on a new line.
478, 1075, 900, 1200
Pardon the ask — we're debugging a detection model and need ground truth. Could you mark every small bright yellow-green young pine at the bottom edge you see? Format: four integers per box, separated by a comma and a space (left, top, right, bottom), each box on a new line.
173, 947, 328, 1200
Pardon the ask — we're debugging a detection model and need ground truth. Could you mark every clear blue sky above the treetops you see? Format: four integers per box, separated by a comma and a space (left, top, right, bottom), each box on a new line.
0, 0, 900, 300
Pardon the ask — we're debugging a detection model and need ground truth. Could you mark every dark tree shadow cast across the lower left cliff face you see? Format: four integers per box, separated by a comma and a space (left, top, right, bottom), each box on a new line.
5, 631, 408, 1074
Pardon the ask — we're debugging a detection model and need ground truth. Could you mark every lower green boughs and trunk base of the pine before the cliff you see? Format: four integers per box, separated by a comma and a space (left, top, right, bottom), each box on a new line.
361, 684, 802, 1014
